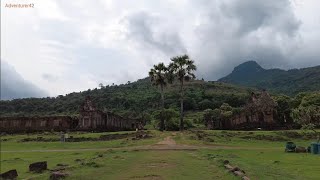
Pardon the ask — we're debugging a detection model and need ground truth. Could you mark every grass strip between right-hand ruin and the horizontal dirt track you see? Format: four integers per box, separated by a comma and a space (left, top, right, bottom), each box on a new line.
174, 130, 316, 149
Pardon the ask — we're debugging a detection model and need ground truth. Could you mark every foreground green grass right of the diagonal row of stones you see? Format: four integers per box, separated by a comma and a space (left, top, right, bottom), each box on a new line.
200, 149, 320, 180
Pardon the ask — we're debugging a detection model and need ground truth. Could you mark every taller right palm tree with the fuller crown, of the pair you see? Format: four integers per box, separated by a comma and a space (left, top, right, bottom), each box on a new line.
168, 54, 197, 131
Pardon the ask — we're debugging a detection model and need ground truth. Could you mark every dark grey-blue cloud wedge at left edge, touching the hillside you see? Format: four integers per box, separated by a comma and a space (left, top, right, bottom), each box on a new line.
1, 60, 47, 100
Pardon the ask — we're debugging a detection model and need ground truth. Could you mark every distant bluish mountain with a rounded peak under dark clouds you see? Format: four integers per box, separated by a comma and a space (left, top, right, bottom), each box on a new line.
218, 61, 320, 95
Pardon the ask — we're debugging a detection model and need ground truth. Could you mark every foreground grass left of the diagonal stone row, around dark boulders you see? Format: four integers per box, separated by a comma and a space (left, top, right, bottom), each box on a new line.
1, 151, 233, 179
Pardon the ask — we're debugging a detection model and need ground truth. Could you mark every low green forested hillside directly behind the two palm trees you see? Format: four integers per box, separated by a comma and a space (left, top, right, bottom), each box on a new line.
0, 78, 254, 117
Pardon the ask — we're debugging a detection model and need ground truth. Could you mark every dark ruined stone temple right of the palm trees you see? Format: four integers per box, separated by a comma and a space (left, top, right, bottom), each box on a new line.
206, 90, 279, 129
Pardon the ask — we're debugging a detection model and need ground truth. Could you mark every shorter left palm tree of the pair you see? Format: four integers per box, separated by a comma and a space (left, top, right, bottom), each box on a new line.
149, 63, 168, 131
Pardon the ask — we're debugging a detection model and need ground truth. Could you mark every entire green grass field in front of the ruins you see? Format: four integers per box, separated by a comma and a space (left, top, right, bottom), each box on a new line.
1, 131, 320, 179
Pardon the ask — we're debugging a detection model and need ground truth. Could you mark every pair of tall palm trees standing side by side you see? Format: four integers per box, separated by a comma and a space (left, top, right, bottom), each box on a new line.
149, 54, 197, 131
